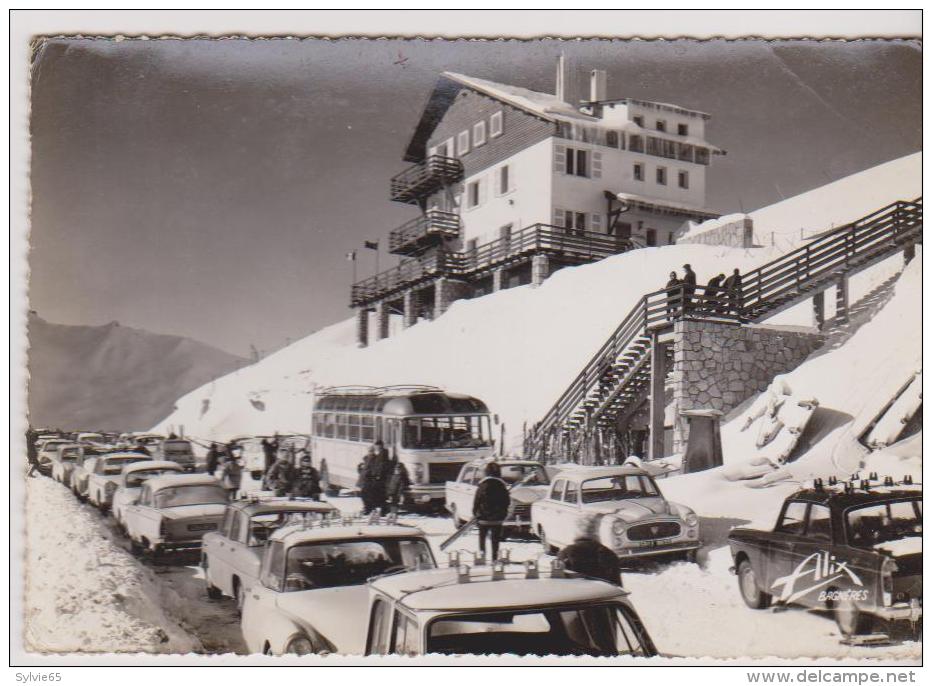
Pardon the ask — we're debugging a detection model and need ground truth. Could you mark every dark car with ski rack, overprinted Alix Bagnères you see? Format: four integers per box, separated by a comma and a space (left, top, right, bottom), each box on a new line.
728, 474, 922, 637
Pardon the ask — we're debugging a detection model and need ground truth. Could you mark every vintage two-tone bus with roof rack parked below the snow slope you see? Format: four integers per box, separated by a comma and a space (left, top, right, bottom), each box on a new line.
311, 386, 492, 507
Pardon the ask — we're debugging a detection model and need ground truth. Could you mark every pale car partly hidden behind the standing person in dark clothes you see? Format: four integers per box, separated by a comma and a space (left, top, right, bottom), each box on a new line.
445, 458, 550, 532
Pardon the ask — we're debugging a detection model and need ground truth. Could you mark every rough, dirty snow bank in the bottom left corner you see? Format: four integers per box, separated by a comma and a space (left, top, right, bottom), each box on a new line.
24, 478, 199, 653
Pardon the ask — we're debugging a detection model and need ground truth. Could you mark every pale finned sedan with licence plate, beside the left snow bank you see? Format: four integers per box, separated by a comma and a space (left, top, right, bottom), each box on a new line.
123, 474, 229, 557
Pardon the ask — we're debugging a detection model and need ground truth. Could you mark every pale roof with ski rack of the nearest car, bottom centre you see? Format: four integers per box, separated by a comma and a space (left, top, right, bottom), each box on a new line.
370, 564, 628, 611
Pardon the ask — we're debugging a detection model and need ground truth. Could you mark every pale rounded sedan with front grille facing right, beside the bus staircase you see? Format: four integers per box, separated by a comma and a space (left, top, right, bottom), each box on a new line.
531, 466, 701, 560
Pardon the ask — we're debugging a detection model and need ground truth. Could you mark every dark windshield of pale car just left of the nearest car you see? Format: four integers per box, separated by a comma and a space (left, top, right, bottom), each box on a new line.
285, 538, 434, 592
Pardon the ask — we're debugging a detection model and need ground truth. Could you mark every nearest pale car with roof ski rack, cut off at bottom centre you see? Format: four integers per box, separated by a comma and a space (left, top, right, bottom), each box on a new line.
364, 563, 657, 657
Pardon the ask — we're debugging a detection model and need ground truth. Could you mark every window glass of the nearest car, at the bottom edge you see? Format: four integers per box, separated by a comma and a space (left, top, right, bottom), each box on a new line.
427, 605, 653, 657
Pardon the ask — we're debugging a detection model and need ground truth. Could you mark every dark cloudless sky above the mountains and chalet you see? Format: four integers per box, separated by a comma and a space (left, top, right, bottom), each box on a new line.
30, 39, 921, 354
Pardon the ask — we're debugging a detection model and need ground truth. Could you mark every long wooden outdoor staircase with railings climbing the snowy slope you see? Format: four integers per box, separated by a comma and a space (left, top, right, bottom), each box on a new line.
525, 197, 922, 458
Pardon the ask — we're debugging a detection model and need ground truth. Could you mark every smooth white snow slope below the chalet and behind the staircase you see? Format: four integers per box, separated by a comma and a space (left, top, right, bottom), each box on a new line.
158, 156, 918, 445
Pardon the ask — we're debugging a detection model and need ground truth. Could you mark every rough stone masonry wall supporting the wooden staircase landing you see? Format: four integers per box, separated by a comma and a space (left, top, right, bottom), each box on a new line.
672, 319, 825, 453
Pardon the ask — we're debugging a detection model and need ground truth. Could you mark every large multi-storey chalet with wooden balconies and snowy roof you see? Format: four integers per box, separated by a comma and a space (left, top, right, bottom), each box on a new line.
351, 60, 723, 345
